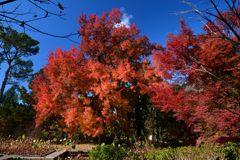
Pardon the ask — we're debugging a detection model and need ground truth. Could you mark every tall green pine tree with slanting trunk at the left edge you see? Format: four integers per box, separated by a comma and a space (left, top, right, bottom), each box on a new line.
0, 26, 39, 104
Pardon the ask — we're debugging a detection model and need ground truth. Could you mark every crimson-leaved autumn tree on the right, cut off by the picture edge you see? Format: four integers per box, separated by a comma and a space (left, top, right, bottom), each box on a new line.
150, 5, 240, 138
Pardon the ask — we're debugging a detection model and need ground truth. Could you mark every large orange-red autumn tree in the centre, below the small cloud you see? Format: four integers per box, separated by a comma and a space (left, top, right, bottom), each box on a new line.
32, 9, 160, 136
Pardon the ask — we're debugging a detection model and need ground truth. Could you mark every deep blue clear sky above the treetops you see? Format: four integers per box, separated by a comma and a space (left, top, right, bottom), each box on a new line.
0, 0, 225, 91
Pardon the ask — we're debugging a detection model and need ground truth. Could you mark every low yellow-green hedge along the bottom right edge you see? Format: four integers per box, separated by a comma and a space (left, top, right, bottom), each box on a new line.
144, 142, 240, 160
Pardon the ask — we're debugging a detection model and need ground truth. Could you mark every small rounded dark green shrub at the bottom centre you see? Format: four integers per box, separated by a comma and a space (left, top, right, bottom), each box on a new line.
89, 143, 127, 160
